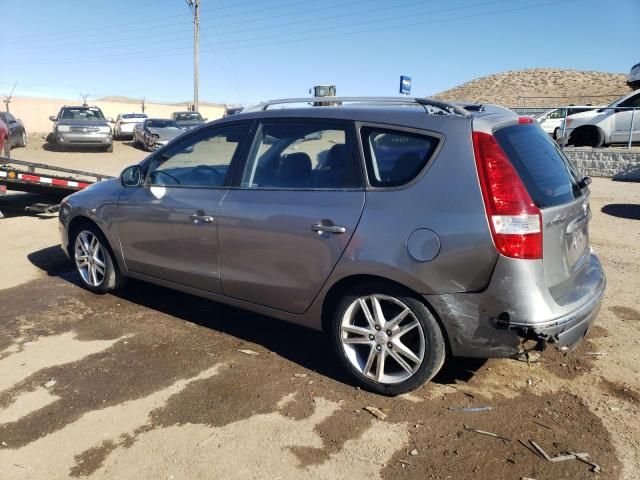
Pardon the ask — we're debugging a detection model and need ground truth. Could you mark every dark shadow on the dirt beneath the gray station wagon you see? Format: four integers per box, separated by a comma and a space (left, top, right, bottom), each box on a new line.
28, 245, 486, 384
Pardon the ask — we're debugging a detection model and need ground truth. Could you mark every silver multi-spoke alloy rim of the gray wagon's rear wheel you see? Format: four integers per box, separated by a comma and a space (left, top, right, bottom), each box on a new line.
340, 294, 425, 384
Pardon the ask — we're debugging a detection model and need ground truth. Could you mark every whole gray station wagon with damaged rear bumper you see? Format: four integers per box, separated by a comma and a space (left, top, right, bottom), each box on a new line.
60, 98, 605, 395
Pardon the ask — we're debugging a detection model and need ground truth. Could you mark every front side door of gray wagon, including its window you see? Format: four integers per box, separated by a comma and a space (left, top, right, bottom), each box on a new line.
117, 123, 250, 293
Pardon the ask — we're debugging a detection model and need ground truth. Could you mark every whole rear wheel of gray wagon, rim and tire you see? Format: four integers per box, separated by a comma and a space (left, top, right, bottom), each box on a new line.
331, 286, 446, 395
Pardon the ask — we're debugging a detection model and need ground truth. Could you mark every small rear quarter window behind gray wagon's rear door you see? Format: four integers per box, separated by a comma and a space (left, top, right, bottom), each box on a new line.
361, 127, 440, 187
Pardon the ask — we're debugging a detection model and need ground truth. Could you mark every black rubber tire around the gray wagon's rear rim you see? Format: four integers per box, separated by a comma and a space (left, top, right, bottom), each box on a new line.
327, 283, 447, 396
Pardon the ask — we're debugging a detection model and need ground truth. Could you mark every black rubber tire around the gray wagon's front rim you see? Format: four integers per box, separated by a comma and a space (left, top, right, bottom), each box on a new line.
69, 223, 125, 295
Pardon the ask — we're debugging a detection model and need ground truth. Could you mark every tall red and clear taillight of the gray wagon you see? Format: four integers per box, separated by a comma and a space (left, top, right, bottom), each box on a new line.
473, 132, 542, 259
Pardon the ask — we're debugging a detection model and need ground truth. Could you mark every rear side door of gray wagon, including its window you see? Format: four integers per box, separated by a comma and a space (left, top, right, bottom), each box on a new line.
218, 119, 365, 313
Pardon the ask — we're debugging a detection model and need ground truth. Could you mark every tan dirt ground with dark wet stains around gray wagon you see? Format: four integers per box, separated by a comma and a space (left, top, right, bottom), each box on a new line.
0, 142, 640, 480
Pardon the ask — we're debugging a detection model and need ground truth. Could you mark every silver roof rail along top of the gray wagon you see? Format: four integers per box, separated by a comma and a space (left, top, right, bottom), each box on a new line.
243, 97, 469, 117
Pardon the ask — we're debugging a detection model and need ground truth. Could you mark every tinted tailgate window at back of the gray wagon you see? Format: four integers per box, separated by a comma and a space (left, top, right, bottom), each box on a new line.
494, 124, 582, 208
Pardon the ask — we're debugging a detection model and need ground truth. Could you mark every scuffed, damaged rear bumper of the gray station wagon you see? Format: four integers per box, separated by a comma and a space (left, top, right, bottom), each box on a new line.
425, 253, 606, 358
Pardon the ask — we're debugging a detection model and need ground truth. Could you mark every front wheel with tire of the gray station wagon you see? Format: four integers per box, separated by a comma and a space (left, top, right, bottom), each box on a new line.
73, 225, 124, 294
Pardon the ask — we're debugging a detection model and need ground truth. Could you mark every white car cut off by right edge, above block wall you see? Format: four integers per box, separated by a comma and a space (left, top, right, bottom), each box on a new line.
559, 90, 640, 148
